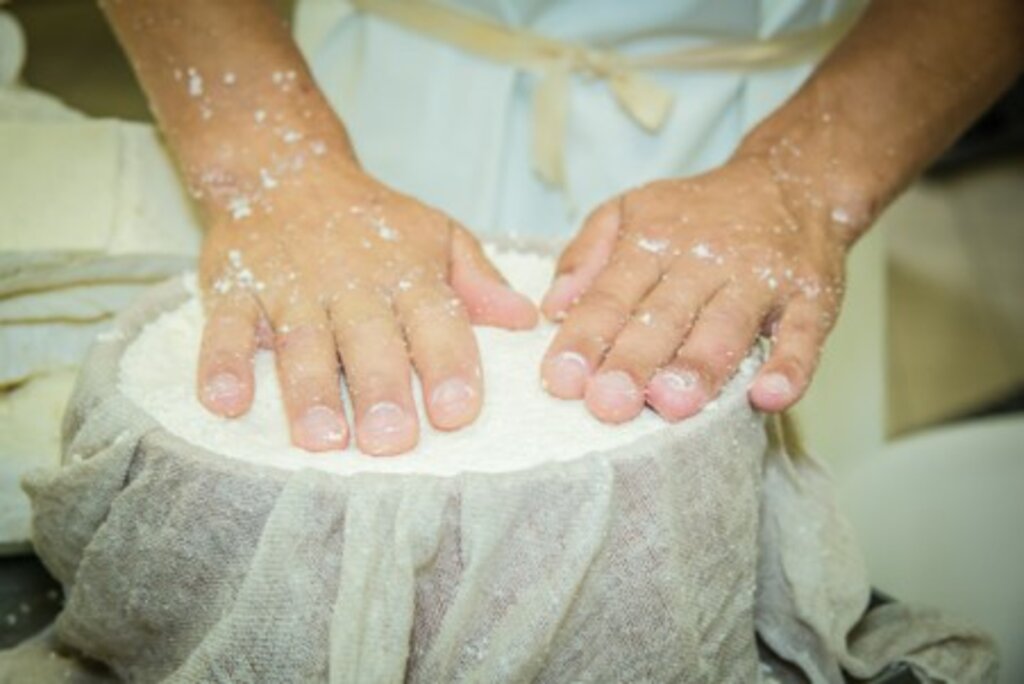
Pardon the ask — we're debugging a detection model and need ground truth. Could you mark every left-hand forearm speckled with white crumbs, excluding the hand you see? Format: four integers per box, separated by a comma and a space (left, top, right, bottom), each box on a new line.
100, 0, 355, 222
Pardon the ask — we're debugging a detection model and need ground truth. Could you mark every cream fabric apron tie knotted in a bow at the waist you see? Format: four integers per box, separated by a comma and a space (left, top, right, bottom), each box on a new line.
351, 0, 862, 187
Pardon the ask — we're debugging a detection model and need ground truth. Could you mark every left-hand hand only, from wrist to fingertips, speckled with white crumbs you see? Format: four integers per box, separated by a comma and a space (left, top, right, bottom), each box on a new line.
194, 166, 537, 455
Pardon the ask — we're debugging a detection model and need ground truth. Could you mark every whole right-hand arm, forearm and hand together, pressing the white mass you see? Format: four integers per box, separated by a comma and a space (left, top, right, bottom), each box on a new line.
542, 0, 1024, 423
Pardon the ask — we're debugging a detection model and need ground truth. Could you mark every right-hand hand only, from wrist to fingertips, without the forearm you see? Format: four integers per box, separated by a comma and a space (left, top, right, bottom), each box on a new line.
542, 157, 848, 423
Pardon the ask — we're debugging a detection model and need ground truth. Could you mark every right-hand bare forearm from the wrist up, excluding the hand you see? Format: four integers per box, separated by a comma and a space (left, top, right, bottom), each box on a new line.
738, 0, 1024, 243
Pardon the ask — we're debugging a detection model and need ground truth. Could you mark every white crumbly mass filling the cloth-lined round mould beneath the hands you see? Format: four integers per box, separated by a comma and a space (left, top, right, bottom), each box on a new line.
120, 253, 757, 476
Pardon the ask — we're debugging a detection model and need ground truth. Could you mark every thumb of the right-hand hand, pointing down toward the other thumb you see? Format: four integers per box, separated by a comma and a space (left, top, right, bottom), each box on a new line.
541, 198, 622, 320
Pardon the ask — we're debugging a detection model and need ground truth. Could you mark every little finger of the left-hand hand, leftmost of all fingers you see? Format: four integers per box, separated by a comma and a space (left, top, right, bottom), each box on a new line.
197, 293, 260, 418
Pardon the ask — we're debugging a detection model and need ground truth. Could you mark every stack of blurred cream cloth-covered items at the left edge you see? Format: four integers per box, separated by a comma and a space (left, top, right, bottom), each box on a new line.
0, 10, 200, 551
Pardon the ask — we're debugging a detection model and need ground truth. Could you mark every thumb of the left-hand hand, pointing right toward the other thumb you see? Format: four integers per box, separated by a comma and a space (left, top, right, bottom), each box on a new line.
452, 226, 537, 330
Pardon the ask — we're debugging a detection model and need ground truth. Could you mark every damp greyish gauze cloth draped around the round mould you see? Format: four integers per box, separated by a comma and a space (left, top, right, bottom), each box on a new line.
0, 281, 994, 683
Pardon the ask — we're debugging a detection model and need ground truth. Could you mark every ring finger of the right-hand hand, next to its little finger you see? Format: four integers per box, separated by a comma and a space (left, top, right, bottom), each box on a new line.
647, 286, 771, 421
